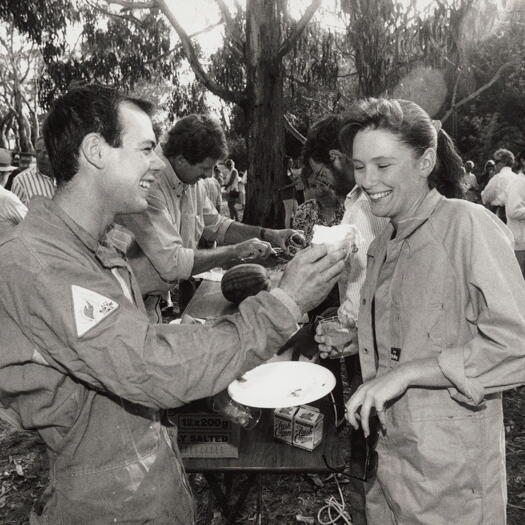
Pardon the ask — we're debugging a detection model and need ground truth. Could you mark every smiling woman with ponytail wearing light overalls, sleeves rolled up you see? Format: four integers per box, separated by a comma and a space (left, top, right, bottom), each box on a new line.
317, 99, 525, 525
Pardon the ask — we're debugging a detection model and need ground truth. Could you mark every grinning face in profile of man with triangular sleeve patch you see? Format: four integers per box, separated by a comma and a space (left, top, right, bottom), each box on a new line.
103, 102, 164, 213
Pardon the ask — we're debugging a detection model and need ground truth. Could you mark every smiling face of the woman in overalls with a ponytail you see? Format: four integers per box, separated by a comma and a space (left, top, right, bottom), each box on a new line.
352, 128, 435, 225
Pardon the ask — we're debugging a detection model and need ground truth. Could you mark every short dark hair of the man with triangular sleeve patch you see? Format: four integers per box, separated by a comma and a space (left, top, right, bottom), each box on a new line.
44, 84, 154, 185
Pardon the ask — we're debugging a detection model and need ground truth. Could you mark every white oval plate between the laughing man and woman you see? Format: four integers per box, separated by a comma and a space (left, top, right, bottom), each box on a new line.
228, 361, 335, 408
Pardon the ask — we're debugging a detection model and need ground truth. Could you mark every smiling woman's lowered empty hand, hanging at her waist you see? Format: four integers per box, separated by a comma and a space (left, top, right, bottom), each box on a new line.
346, 366, 409, 437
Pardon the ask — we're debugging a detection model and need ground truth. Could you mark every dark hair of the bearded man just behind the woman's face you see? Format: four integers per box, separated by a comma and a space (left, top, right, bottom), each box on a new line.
303, 115, 343, 166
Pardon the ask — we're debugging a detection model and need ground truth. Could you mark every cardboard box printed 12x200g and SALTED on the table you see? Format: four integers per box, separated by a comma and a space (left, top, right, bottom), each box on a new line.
176, 412, 241, 458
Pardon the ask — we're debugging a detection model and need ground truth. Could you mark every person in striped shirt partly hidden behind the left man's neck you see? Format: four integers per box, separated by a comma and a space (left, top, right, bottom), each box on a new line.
11, 137, 56, 206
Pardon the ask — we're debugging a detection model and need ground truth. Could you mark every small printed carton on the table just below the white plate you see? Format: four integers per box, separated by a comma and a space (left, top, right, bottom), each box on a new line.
273, 405, 324, 450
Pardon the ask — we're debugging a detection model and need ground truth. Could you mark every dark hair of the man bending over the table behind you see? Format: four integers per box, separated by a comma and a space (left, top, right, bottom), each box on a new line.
162, 115, 228, 165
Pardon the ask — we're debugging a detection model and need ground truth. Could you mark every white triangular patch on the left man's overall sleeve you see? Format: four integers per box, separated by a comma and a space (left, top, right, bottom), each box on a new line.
71, 284, 118, 337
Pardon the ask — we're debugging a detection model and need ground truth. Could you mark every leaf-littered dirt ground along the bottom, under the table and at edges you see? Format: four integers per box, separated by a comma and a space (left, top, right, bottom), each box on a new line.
0, 388, 525, 525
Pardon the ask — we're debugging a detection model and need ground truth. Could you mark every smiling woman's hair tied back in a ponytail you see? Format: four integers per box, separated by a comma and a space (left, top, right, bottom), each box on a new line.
339, 98, 464, 197
